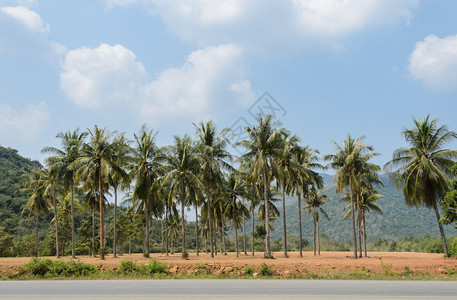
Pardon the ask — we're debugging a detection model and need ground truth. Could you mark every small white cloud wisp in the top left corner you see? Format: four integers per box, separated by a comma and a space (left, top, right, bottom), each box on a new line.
0, 6, 49, 33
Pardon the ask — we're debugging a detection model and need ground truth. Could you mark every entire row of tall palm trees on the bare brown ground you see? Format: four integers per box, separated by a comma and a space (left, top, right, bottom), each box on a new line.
21, 116, 457, 259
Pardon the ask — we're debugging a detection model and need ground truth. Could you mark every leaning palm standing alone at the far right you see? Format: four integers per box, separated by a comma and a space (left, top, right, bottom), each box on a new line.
384, 115, 457, 257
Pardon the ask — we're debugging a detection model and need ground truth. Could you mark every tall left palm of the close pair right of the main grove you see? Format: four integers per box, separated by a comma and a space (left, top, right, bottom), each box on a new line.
323, 134, 380, 259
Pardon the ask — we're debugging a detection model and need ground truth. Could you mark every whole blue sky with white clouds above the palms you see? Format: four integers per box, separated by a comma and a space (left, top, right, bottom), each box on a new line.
0, 0, 457, 168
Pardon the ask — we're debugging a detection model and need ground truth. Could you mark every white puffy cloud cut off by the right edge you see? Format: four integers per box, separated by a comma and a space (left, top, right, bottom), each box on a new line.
408, 35, 457, 92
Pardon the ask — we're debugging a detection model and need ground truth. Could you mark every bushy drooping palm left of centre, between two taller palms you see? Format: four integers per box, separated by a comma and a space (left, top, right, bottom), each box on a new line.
163, 135, 202, 258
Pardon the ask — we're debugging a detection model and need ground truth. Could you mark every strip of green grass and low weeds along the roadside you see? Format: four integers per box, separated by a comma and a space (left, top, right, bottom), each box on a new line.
0, 258, 457, 281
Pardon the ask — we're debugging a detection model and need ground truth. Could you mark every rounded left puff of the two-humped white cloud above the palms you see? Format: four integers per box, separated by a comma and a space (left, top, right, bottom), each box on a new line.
60, 44, 147, 109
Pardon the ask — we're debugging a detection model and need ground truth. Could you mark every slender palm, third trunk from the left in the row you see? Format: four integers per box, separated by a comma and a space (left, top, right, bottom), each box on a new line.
41, 129, 87, 258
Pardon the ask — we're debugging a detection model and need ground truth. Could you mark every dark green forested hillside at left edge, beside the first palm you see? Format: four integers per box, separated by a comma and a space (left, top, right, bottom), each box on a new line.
0, 146, 41, 235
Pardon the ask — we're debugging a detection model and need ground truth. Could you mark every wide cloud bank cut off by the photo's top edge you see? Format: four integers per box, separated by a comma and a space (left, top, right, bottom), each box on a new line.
105, 0, 419, 51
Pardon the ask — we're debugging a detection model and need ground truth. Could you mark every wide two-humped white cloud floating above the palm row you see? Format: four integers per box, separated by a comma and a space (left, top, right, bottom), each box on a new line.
60, 44, 253, 122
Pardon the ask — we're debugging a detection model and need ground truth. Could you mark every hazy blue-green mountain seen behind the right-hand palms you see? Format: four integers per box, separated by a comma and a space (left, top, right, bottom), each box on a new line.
268, 174, 457, 242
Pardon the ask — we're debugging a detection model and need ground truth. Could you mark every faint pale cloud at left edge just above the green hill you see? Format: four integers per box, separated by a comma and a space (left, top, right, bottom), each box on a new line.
0, 102, 49, 145
